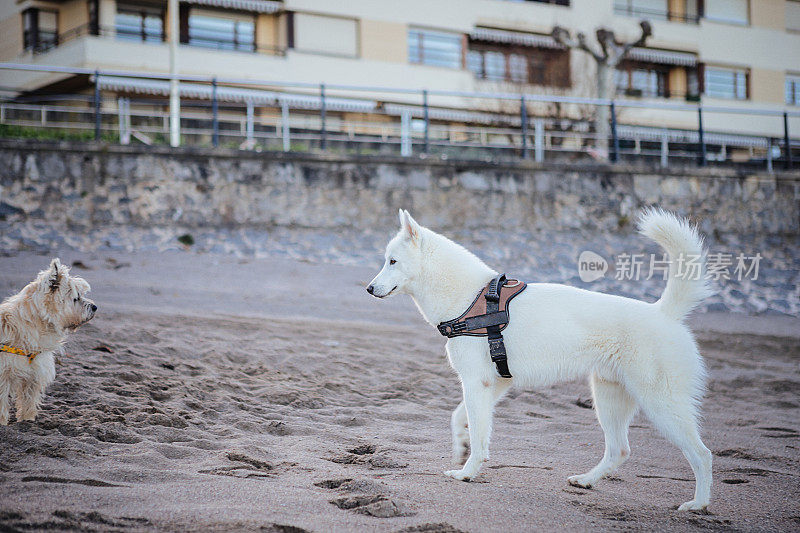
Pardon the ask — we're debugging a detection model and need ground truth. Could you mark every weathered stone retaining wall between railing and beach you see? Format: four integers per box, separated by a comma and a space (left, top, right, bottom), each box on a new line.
0, 141, 800, 236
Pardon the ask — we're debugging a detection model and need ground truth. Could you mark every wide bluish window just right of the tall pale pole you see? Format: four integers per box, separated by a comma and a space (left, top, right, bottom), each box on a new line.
189, 9, 256, 52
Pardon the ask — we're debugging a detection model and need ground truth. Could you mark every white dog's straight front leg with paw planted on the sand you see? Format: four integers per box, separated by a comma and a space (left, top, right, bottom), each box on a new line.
445, 381, 494, 481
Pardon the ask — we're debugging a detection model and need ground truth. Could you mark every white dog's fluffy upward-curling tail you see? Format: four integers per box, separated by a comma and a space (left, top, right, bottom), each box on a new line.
639, 208, 711, 320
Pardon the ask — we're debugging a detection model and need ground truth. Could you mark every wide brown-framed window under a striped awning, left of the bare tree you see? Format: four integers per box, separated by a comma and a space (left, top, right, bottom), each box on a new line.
467, 41, 570, 87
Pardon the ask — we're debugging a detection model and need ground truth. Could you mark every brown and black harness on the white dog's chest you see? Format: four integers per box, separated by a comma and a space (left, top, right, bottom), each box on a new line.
436, 274, 528, 378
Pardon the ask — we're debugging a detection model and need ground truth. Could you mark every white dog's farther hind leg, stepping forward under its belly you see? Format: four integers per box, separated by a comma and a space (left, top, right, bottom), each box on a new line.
567, 374, 636, 489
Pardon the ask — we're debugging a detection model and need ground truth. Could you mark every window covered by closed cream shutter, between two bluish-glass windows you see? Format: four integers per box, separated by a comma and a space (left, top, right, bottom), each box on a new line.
294, 13, 358, 57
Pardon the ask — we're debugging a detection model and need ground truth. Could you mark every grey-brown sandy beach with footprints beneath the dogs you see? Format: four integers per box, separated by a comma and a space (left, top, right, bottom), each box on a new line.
0, 252, 800, 533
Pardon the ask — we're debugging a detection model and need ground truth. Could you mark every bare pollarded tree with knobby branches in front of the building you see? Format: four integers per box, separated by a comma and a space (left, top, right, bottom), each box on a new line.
552, 20, 653, 157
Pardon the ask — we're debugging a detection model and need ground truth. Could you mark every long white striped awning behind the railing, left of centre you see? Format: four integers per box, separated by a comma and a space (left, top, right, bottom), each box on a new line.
99, 76, 376, 112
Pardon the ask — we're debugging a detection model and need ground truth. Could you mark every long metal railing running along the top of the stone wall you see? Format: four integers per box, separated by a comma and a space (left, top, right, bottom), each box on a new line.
0, 63, 800, 171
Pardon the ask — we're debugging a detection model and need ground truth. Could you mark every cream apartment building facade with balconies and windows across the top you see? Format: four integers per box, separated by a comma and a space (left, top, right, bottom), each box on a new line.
0, 0, 800, 141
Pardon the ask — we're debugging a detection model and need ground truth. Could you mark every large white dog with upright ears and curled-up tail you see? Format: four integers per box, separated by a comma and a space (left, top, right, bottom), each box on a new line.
367, 209, 711, 511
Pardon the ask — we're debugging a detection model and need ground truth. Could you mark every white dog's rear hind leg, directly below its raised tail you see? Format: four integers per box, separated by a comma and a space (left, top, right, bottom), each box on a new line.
642, 398, 711, 511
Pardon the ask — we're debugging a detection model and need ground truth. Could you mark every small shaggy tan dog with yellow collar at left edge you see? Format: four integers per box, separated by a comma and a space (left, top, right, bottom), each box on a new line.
0, 259, 97, 425
